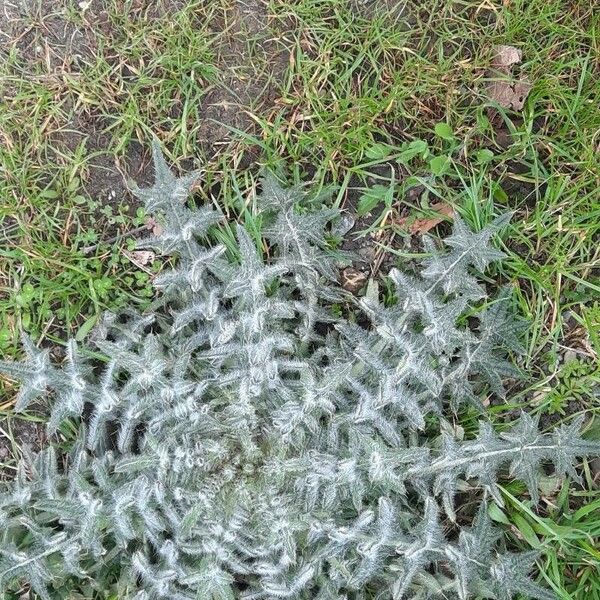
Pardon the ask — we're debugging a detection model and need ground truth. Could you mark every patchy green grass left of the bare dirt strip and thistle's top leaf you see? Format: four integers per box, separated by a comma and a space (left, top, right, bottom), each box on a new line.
0, 2, 223, 380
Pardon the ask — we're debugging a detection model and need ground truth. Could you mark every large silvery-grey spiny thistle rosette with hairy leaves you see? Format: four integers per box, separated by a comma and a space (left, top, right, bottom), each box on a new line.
0, 143, 600, 600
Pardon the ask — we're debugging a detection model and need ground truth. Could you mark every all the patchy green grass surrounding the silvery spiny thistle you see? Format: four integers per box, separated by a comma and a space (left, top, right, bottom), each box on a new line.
0, 0, 600, 600
